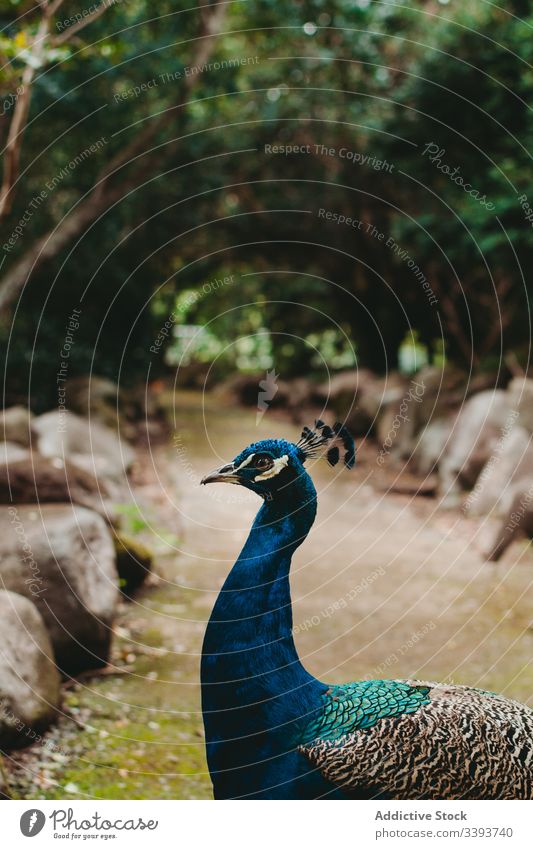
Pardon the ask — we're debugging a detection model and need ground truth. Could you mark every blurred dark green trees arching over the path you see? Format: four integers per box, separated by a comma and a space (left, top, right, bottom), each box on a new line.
0, 0, 533, 410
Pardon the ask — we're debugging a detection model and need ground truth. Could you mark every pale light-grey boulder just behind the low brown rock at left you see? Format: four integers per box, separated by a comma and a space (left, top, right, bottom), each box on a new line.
32, 410, 135, 484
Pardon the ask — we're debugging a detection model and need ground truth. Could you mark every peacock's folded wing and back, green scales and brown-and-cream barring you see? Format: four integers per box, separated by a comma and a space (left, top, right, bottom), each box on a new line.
299, 681, 533, 799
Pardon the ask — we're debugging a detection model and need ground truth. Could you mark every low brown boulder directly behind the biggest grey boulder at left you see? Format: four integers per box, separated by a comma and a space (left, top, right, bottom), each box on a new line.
0, 449, 109, 515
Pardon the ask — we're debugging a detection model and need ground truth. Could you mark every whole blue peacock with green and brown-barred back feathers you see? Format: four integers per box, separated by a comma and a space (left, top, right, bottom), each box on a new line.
201, 420, 533, 800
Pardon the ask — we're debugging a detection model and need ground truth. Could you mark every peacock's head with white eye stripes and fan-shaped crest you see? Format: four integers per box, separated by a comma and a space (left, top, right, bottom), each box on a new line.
201, 419, 355, 501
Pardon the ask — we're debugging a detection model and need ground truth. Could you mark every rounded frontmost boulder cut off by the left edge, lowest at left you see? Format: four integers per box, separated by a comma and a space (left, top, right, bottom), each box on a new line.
0, 590, 60, 746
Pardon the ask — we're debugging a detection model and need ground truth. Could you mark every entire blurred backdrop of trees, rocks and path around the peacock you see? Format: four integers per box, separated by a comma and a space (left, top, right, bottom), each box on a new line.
0, 0, 533, 799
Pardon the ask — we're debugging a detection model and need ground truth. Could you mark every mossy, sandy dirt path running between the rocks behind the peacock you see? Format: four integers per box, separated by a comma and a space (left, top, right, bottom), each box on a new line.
11, 394, 533, 799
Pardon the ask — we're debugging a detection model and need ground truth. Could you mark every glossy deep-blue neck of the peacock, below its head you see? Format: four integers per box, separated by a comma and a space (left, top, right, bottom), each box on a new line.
202, 472, 326, 792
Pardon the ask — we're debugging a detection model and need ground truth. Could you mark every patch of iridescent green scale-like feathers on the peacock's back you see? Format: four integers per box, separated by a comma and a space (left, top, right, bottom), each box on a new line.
301, 681, 429, 746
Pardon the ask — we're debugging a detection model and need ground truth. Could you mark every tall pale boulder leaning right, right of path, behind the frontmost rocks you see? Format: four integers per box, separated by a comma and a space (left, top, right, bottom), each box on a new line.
439, 389, 513, 506
